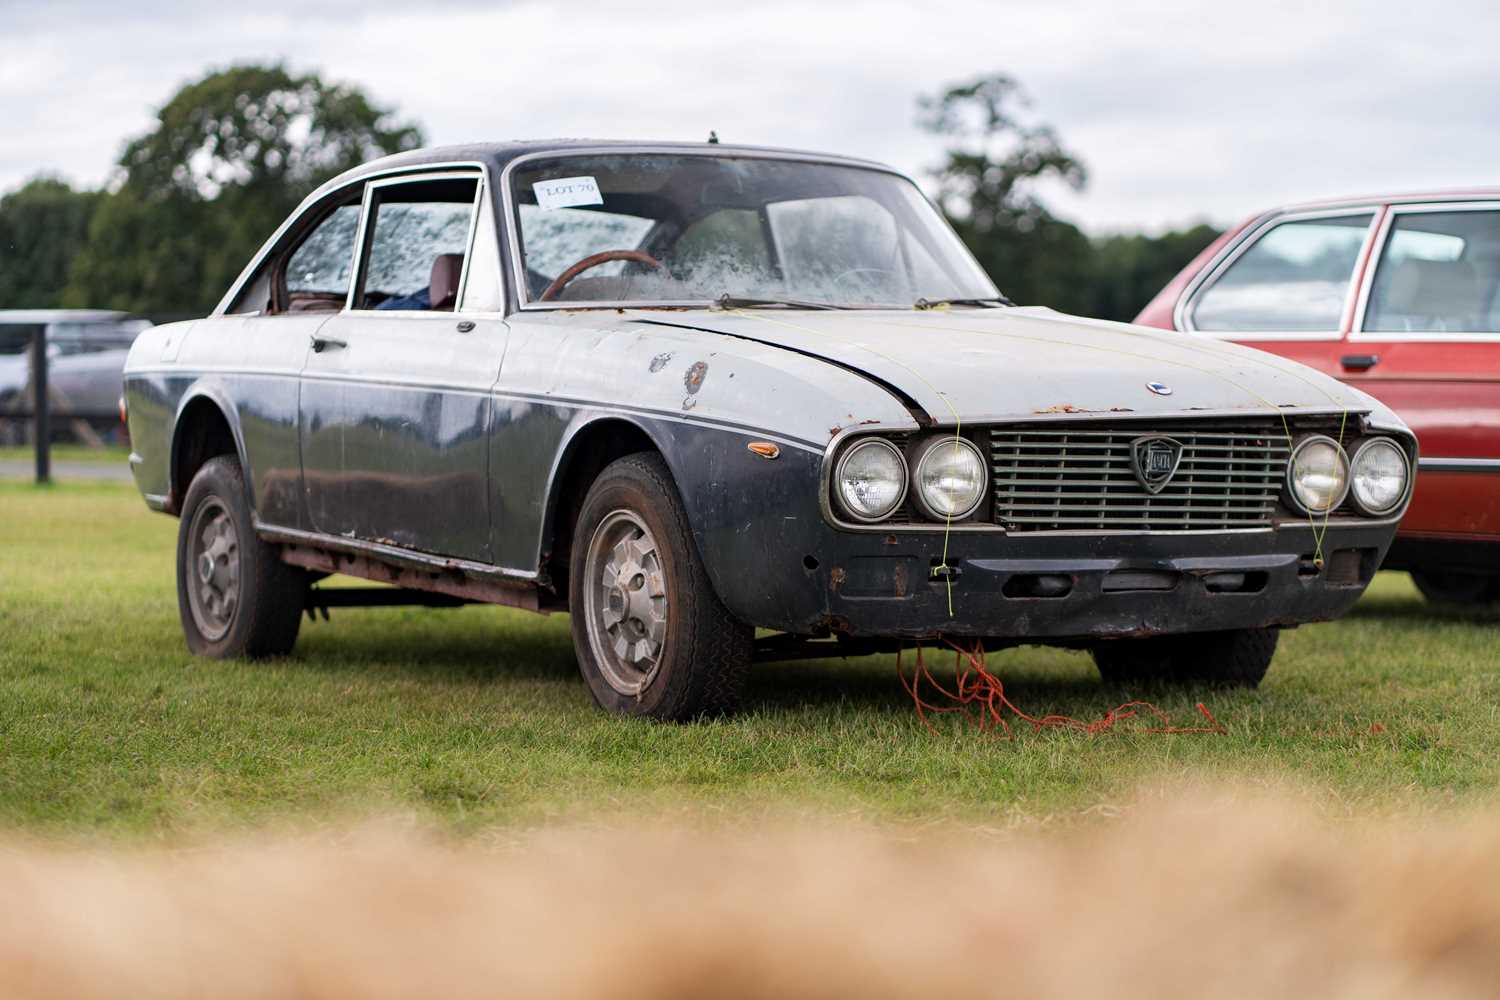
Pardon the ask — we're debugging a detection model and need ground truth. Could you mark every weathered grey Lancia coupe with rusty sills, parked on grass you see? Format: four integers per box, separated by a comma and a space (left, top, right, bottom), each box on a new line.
126, 141, 1416, 720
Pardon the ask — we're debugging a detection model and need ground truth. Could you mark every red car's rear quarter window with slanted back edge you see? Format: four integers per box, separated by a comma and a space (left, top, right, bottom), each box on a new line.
1191, 213, 1373, 333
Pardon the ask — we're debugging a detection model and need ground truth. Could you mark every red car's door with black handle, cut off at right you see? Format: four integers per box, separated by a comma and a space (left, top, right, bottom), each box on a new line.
1343, 201, 1500, 541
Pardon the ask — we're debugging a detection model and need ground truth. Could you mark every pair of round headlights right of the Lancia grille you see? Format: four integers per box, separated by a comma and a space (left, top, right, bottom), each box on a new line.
1287, 435, 1412, 516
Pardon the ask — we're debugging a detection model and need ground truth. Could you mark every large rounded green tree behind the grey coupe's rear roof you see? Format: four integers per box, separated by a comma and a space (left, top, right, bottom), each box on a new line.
66, 66, 422, 313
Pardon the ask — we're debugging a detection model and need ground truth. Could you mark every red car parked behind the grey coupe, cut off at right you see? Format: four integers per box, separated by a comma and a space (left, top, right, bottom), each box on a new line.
1136, 189, 1500, 604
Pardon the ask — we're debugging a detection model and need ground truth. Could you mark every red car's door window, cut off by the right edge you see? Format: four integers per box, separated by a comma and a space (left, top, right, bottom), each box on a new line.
1364, 211, 1500, 333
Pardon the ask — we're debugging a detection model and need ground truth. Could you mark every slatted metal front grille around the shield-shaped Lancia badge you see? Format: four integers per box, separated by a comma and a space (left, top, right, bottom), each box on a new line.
990, 418, 1326, 531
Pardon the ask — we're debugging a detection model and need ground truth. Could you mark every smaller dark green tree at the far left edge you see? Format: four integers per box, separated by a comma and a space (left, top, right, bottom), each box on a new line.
0, 177, 99, 309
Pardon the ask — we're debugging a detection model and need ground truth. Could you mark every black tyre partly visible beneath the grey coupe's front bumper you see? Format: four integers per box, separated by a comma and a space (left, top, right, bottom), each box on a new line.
1094, 628, 1281, 688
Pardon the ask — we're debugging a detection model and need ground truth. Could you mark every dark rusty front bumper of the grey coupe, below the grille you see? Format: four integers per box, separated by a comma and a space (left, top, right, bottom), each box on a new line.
705, 512, 1395, 643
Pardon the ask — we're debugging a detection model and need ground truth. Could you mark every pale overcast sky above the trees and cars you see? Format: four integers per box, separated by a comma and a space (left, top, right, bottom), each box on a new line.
0, 0, 1500, 232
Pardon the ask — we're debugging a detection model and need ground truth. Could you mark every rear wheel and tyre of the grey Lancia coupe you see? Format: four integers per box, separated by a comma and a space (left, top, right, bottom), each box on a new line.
177, 456, 308, 660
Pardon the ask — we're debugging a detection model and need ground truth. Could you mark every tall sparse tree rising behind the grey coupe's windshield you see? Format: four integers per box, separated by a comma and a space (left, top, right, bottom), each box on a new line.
918, 75, 1092, 312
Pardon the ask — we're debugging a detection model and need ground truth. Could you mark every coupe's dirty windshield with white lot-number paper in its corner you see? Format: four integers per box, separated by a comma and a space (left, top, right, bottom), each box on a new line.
512, 153, 998, 307
